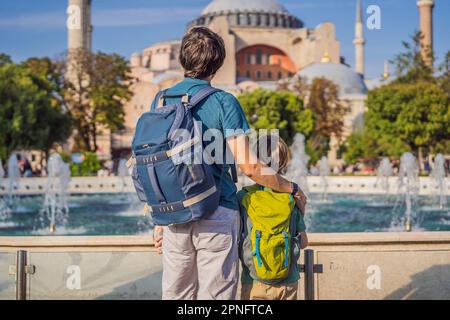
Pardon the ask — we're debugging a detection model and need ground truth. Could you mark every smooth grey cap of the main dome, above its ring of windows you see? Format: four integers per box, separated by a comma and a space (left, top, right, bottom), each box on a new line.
202, 0, 288, 15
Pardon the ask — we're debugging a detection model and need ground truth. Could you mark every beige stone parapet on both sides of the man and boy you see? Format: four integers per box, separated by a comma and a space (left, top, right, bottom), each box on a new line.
0, 232, 450, 300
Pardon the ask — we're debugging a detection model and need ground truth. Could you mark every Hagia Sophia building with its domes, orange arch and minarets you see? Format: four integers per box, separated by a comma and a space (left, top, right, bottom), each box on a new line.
68, 0, 434, 164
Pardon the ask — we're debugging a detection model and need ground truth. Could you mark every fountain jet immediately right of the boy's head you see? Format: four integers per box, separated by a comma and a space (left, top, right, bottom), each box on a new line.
287, 133, 310, 195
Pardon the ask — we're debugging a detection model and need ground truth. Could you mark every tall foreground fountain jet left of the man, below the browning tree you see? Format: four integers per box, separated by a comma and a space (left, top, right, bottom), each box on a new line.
41, 153, 70, 233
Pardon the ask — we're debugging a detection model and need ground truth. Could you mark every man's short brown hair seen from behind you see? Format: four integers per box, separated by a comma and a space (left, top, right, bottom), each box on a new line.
180, 27, 226, 79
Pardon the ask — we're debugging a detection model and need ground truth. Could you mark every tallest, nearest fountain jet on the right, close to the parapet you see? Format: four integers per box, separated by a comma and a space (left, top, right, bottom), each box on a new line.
398, 152, 419, 232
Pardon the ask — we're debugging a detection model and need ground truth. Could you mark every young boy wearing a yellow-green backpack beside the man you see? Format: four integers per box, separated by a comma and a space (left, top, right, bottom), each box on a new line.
238, 136, 308, 300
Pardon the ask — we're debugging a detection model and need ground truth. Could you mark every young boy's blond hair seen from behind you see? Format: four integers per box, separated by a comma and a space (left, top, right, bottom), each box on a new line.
257, 135, 291, 174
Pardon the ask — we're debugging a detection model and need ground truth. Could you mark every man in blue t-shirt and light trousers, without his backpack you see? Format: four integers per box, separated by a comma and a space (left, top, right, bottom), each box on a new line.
153, 27, 306, 300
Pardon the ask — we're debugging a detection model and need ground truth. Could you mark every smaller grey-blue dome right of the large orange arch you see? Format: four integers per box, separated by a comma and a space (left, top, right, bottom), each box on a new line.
294, 63, 367, 96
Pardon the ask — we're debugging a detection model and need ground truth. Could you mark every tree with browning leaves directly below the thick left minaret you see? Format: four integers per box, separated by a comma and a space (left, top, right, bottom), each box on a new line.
60, 50, 132, 152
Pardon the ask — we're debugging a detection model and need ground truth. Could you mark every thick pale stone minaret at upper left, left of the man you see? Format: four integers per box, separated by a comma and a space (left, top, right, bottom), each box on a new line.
67, 0, 92, 52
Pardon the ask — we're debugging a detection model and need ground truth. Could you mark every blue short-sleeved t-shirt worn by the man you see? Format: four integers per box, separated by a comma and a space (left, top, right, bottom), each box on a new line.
166, 78, 250, 210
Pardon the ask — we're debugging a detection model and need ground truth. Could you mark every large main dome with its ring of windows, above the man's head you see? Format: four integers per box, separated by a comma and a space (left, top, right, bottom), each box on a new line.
188, 0, 303, 29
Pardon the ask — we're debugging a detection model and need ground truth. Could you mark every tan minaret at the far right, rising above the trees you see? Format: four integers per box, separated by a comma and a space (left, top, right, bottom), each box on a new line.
417, 0, 434, 67
